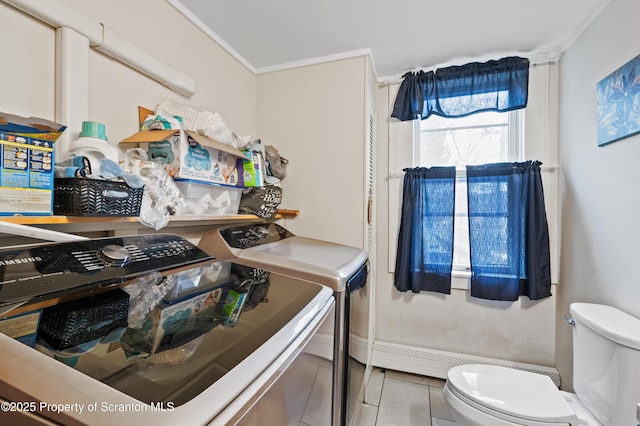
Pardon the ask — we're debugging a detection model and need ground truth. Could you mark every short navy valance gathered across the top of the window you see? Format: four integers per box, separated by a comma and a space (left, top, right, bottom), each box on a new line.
391, 56, 529, 121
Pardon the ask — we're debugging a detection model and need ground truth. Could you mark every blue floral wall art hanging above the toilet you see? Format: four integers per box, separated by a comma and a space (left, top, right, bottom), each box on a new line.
598, 55, 640, 146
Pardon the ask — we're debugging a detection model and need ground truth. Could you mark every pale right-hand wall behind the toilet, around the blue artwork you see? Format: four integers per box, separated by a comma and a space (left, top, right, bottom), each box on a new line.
556, 0, 640, 388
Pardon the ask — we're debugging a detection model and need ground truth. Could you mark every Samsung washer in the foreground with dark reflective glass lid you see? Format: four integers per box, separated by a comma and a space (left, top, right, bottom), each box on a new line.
0, 234, 335, 425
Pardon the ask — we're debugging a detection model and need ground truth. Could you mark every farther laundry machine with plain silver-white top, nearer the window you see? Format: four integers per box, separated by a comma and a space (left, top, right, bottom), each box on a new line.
199, 223, 368, 425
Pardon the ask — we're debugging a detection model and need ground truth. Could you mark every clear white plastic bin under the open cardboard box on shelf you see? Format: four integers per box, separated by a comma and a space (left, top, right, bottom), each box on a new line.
175, 179, 244, 215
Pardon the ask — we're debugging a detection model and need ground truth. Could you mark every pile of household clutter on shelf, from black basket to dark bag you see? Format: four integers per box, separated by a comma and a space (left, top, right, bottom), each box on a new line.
41, 101, 287, 226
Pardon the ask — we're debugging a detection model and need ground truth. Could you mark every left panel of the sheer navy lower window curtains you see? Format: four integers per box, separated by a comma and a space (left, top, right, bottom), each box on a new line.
394, 167, 456, 294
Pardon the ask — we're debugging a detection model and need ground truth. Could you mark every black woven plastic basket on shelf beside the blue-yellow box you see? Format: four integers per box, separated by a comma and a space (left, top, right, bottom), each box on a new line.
53, 178, 144, 216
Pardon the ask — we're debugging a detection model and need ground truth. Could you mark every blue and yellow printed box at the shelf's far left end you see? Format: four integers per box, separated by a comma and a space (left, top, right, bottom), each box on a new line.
0, 113, 66, 216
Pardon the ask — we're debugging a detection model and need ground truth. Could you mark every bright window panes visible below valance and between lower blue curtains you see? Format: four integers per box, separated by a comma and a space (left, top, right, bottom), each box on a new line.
414, 110, 523, 273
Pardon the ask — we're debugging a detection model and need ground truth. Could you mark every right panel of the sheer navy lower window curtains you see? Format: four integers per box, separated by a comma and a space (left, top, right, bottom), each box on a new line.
467, 161, 551, 301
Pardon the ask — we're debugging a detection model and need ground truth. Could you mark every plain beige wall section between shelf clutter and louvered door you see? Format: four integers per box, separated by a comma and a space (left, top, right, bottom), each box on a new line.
257, 57, 367, 247
